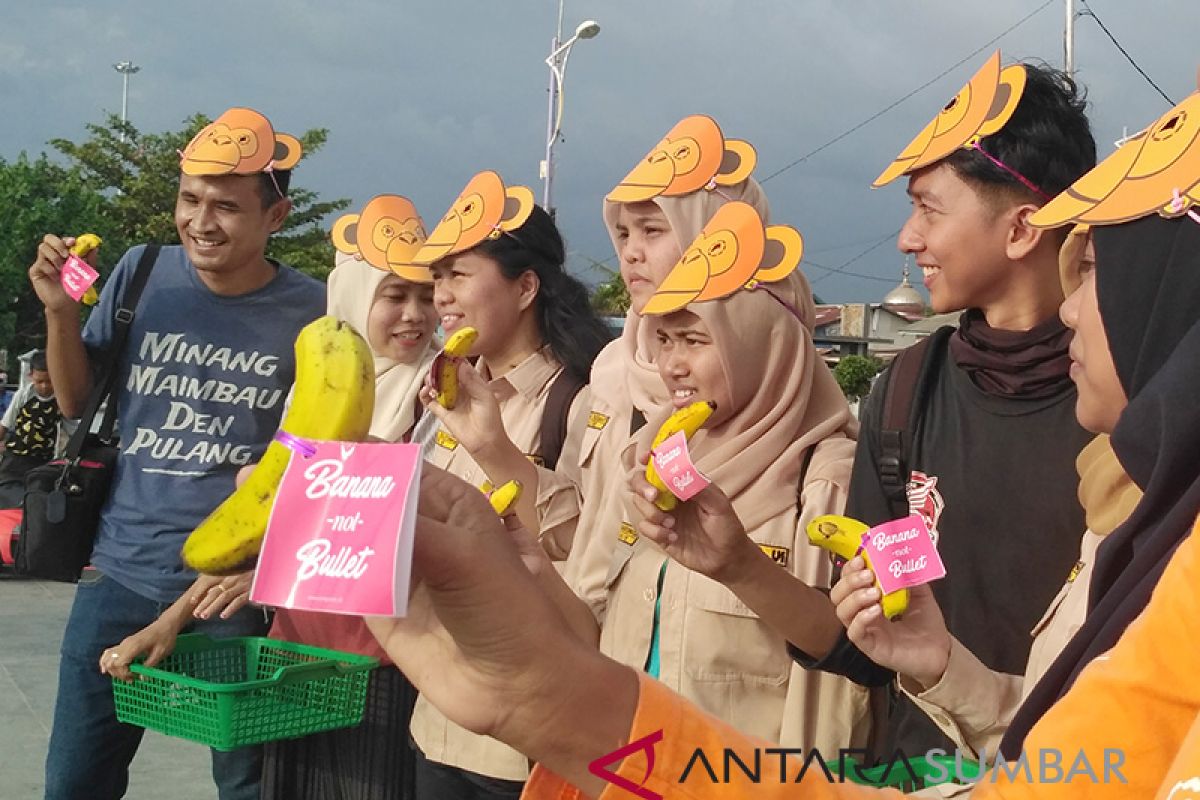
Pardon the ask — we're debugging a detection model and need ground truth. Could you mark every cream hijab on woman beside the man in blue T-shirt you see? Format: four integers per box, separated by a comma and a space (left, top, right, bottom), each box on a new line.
326, 253, 437, 441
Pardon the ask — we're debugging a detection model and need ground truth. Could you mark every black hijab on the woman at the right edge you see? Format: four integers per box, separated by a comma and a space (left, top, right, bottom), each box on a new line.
1001, 215, 1200, 758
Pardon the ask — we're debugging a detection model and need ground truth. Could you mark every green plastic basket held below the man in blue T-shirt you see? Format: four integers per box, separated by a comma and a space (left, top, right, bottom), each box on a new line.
113, 633, 379, 750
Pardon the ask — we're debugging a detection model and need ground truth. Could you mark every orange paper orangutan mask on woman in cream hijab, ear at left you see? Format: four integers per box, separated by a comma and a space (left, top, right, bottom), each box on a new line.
331, 194, 433, 283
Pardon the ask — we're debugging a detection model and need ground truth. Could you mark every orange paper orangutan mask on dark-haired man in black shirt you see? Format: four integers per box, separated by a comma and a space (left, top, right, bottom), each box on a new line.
871, 50, 1025, 188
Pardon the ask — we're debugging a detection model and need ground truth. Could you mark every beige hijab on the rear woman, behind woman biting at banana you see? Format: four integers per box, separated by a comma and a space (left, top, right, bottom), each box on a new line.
590, 178, 772, 415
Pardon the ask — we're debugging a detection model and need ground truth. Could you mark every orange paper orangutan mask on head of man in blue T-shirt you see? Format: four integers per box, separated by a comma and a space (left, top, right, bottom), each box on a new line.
180, 108, 301, 175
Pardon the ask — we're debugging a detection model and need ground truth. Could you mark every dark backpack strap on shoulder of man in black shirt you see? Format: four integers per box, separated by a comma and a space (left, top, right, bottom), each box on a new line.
876, 325, 954, 518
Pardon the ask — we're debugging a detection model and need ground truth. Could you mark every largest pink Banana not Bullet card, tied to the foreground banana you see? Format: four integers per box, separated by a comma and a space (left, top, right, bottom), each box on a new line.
250, 441, 421, 616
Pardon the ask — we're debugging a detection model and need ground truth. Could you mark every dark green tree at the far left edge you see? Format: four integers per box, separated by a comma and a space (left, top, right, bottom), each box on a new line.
0, 155, 110, 367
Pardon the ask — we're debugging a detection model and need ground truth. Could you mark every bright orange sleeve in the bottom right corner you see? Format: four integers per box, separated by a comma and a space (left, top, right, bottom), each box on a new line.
971, 525, 1200, 800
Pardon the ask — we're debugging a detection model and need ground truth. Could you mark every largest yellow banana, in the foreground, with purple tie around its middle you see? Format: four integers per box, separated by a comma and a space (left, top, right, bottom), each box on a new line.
182, 317, 374, 575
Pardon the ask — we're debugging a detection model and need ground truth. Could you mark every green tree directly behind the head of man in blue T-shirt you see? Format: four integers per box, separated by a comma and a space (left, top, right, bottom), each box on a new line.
50, 114, 349, 279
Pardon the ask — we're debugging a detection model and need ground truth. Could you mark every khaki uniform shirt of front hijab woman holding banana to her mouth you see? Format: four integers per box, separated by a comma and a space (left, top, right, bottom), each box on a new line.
564, 439, 870, 752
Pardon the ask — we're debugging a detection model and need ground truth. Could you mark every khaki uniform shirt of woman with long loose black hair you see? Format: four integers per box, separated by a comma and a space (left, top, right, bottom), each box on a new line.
410, 349, 589, 781
